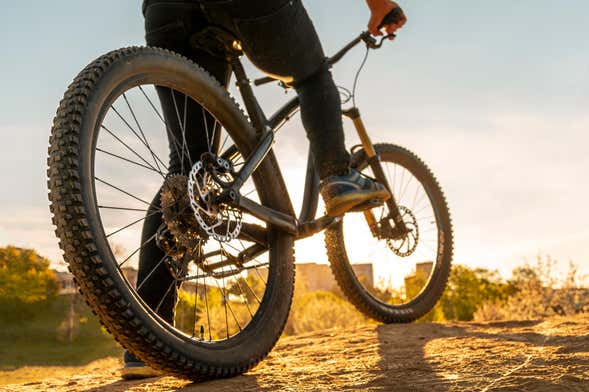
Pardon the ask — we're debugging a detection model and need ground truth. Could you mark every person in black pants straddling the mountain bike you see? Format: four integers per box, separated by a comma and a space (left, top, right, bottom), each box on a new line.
123, 0, 406, 378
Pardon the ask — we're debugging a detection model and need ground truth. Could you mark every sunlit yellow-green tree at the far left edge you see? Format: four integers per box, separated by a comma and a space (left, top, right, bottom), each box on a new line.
0, 246, 58, 322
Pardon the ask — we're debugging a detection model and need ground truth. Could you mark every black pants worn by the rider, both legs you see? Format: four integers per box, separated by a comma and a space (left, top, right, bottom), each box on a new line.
138, 0, 349, 321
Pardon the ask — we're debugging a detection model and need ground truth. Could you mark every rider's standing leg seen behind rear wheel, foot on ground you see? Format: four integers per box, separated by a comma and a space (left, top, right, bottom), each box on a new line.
122, 0, 230, 378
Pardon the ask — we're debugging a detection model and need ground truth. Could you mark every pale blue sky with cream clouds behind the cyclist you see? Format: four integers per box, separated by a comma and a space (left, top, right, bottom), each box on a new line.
0, 0, 589, 276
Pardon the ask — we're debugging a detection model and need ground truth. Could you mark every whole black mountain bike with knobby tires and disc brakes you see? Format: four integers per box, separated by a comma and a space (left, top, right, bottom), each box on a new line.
48, 27, 453, 380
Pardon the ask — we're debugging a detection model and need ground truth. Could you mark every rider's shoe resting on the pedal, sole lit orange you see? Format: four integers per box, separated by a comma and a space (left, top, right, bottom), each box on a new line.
320, 169, 391, 217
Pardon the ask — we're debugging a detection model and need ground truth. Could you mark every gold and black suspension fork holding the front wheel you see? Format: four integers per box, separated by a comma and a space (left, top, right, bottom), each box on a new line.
343, 107, 407, 235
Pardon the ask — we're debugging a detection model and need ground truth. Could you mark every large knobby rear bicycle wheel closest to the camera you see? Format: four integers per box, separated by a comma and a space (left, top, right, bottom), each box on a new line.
48, 48, 294, 380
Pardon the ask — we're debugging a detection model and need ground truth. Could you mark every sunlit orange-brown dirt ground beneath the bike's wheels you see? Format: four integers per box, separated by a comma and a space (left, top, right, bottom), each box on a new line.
0, 315, 589, 392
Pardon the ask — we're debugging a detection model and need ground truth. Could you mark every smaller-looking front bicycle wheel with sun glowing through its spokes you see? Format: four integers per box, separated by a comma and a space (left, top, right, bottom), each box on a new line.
325, 144, 453, 323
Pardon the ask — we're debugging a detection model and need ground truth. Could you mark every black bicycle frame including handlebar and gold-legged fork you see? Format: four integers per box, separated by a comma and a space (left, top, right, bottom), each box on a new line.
215, 32, 406, 239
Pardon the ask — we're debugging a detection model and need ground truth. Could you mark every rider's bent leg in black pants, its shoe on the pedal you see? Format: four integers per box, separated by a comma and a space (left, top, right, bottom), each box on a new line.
204, 0, 389, 215
